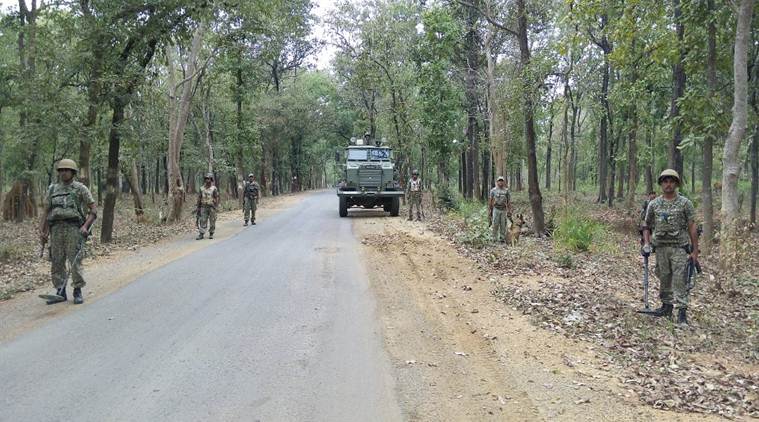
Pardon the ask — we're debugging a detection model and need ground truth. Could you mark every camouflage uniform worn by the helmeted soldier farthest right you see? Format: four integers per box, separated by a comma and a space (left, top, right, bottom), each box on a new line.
645, 195, 696, 309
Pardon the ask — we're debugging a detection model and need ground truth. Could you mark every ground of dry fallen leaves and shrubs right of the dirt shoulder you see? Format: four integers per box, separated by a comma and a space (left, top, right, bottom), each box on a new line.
428, 195, 759, 417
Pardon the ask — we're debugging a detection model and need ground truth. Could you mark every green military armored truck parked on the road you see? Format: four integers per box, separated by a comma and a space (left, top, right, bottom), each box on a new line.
337, 136, 404, 217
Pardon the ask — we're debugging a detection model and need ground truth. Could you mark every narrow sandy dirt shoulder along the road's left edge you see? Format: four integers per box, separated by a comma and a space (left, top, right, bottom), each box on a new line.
0, 194, 303, 343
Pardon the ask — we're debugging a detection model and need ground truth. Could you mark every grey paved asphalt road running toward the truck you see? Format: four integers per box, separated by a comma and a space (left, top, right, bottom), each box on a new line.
0, 192, 402, 422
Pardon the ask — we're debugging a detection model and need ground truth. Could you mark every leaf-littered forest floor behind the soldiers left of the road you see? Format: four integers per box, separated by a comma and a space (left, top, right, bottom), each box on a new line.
0, 195, 236, 300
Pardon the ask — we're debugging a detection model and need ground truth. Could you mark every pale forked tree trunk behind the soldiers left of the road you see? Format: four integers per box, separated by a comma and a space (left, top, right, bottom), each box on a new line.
166, 22, 207, 222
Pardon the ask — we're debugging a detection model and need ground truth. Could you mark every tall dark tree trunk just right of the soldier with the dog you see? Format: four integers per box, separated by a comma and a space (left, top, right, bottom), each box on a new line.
517, 0, 545, 236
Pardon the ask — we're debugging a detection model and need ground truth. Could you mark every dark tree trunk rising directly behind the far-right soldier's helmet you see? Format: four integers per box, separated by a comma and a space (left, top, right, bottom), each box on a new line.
667, 0, 686, 177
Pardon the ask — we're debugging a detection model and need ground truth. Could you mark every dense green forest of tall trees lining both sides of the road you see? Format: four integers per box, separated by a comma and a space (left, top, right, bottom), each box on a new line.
0, 0, 759, 274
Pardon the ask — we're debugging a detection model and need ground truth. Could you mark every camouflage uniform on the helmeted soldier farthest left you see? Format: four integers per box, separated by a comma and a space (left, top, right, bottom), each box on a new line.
46, 181, 95, 289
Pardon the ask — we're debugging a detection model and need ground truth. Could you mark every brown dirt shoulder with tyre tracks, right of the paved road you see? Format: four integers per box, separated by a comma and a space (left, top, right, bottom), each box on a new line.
354, 217, 717, 421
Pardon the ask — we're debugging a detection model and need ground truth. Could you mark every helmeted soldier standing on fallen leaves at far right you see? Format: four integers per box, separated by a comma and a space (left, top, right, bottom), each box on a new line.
643, 169, 698, 324
